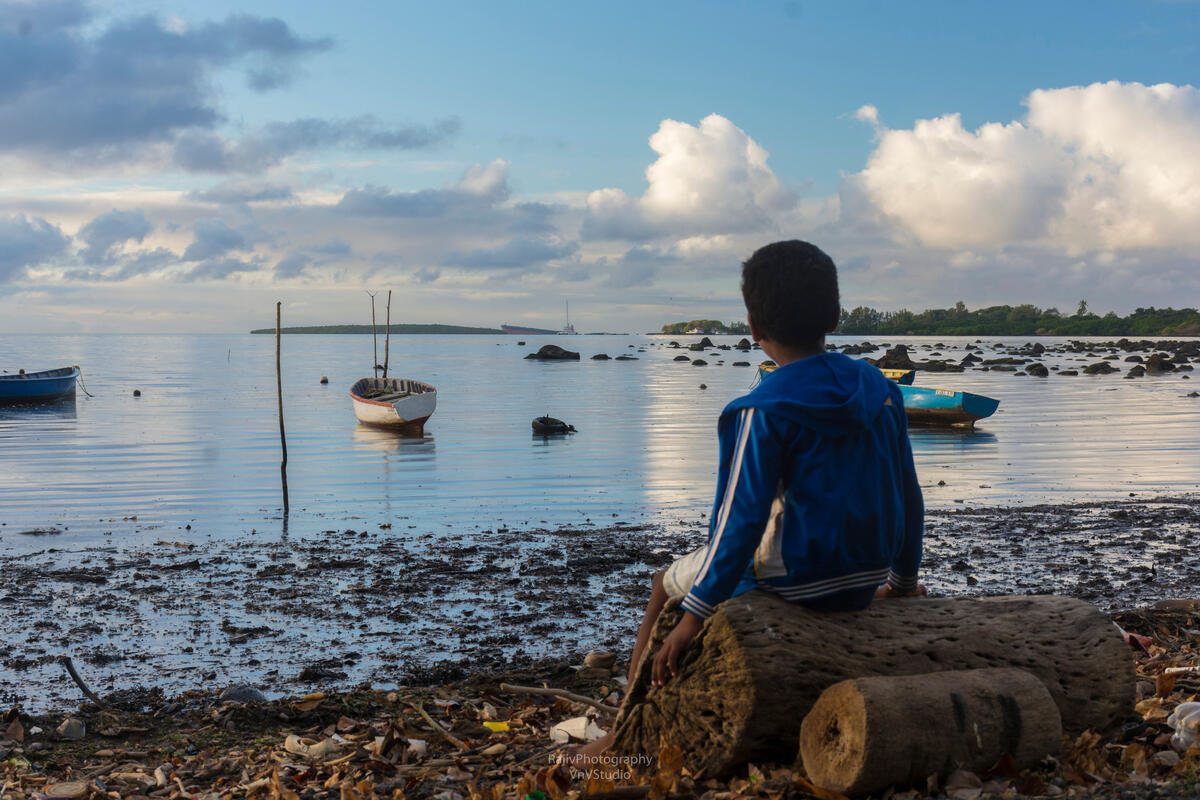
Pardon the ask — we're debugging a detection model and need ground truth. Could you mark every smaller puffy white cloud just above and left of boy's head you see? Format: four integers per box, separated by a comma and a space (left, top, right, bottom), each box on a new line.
583, 114, 796, 241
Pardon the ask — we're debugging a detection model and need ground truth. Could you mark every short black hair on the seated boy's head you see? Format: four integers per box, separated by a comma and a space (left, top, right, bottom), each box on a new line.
742, 239, 841, 347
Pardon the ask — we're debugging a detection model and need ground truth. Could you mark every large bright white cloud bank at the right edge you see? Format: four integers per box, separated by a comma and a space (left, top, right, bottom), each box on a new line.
851, 82, 1200, 255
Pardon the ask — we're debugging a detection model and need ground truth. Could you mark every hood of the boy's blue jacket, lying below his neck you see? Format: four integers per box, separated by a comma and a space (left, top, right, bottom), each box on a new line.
721, 353, 901, 435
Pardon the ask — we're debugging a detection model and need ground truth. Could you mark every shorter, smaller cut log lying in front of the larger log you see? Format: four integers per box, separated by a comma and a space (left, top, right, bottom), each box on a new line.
800, 669, 1062, 795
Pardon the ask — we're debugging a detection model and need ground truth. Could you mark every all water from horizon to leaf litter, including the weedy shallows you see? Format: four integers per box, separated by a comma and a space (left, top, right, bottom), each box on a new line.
0, 336, 1200, 709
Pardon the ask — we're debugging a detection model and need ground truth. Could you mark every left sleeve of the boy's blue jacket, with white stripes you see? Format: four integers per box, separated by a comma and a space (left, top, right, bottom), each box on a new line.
683, 408, 784, 619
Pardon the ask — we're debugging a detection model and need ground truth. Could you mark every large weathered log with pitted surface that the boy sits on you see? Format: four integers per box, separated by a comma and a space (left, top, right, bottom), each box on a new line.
614, 591, 1134, 777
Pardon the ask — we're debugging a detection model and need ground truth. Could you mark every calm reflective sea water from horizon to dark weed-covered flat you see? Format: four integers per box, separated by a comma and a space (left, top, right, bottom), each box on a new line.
0, 335, 1200, 552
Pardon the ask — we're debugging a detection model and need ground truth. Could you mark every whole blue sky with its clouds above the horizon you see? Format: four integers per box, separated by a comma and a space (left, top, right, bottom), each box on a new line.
0, 0, 1200, 331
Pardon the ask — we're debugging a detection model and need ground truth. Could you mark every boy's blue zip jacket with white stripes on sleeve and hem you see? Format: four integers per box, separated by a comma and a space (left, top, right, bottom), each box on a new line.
683, 353, 924, 618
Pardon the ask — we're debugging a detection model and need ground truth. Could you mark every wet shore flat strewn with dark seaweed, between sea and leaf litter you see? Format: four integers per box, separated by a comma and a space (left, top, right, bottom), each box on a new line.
0, 494, 1200, 710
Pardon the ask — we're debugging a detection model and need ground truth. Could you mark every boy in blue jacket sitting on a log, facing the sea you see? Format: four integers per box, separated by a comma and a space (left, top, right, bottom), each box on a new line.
571, 240, 924, 760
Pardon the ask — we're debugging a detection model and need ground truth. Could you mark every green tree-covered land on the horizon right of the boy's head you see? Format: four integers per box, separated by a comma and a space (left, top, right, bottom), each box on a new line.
835, 300, 1200, 336
